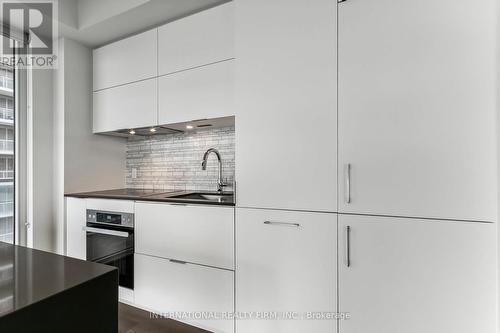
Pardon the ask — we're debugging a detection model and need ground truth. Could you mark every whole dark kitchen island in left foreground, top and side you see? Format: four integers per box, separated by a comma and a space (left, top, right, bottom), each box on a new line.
0, 242, 118, 333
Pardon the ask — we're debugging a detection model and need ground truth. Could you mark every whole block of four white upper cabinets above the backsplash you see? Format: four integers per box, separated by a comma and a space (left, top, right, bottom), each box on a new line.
93, 3, 235, 133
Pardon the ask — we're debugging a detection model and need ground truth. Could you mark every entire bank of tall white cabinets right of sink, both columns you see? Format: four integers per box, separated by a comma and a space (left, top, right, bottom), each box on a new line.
235, 0, 497, 333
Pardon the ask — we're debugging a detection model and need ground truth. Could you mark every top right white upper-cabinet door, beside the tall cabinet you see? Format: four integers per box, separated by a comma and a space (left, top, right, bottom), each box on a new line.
158, 2, 234, 75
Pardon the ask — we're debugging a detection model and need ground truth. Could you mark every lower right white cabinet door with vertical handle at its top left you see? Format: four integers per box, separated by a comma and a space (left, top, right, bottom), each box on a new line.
339, 215, 497, 333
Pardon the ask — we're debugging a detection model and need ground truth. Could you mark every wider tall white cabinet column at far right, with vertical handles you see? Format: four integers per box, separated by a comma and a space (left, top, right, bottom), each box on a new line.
338, 0, 498, 333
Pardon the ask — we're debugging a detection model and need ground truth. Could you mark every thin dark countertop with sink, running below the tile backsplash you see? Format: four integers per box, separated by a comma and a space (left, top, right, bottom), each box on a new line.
64, 188, 235, 206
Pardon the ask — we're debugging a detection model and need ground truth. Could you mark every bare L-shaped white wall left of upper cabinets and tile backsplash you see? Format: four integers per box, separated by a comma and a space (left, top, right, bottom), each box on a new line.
63, 39, 126, 193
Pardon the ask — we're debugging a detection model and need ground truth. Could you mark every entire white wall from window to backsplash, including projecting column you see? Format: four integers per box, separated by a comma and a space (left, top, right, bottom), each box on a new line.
32, 38, 126, 253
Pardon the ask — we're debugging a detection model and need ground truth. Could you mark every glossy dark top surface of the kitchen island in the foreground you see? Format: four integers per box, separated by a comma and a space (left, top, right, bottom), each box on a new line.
0, 242, 118, 318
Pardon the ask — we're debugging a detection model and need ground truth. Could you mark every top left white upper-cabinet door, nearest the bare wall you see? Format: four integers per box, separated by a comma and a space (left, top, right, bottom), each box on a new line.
93, 29, 158, 91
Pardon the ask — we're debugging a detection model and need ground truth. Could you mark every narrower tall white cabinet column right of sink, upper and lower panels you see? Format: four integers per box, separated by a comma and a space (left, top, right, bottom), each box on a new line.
235, 0, 337, 333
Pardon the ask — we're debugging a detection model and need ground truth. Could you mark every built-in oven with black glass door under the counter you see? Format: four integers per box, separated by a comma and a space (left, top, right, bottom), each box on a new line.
85, 209, 134, 289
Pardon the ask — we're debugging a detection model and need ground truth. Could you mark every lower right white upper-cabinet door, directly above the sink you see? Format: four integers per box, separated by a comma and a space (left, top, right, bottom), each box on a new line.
158, 60, 235, 124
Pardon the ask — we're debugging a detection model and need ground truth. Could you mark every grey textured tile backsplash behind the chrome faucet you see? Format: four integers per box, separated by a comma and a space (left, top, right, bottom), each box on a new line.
126, 127, 235, 191
